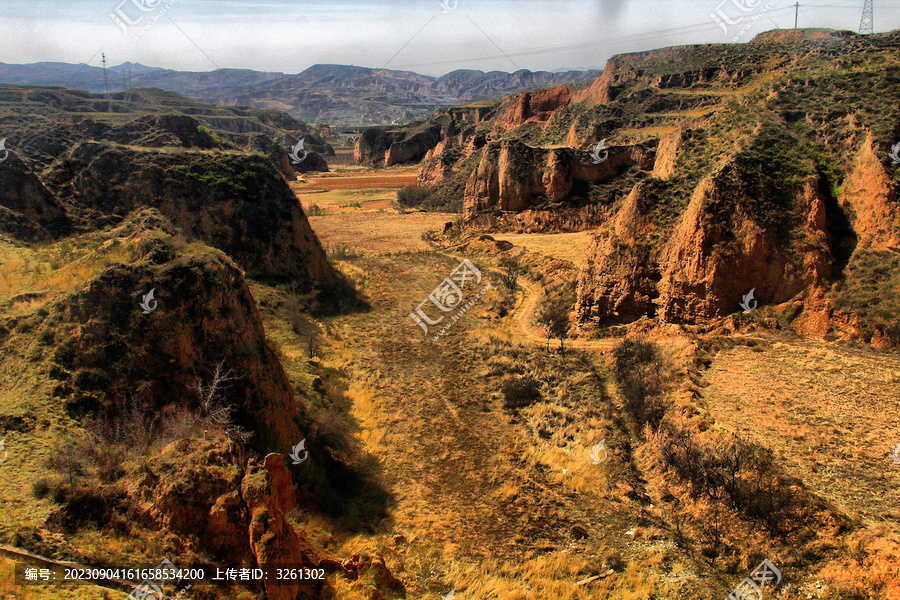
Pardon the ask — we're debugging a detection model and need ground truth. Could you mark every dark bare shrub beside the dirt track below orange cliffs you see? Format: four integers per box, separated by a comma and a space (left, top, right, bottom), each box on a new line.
613, 338, 666, 429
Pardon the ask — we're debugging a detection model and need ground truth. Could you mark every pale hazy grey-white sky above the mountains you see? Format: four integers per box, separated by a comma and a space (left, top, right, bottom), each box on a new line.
0, 0, 900, 75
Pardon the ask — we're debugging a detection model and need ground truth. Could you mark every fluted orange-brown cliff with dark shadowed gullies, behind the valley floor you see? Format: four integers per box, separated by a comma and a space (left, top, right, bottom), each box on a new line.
463, 141, 654, 220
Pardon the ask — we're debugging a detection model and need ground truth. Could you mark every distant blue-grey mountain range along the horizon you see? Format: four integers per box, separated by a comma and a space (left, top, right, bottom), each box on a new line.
0, 62, 602, 125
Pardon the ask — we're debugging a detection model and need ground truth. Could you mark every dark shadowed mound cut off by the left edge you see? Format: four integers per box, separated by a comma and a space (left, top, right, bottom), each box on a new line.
0, 151, 71, 241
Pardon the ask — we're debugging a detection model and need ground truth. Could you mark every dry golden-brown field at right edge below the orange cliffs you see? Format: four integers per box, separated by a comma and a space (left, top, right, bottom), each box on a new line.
703, 334, 900, 526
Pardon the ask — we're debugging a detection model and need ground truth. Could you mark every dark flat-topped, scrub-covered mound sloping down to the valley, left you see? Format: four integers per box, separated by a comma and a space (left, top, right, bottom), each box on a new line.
46, 142, 334, 290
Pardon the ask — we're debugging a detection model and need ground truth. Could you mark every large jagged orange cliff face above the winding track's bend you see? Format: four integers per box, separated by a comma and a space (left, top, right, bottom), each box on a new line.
577, 167, 832, 324
